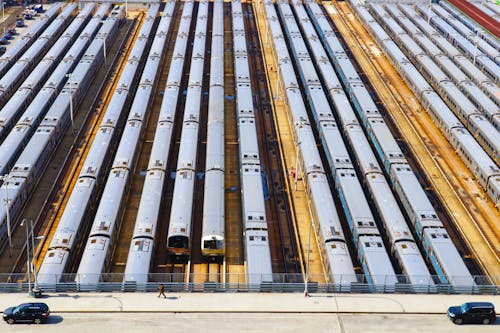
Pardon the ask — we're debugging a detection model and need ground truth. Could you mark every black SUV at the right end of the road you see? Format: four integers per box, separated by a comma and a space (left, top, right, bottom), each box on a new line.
448, 302, 497, 325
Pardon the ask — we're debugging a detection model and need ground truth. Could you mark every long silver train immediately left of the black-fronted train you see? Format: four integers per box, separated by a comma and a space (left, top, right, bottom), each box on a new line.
124, 1, 188, 284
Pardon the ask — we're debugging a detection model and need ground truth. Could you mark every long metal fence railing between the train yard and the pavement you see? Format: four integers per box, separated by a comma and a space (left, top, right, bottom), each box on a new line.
0, 273, 500, 295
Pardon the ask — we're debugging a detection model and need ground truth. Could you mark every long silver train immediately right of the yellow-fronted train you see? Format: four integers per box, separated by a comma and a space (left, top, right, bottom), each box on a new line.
231, 0, 273, 287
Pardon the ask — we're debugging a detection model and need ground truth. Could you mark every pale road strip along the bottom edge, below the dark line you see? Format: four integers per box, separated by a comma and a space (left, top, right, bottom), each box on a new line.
0, 313, 500, 333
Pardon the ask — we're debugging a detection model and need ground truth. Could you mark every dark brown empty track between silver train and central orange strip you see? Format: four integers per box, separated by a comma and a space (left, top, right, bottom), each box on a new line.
243, 3, 300, 274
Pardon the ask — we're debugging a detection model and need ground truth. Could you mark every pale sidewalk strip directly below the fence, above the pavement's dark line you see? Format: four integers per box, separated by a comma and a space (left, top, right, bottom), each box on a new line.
0, 293, 500, 314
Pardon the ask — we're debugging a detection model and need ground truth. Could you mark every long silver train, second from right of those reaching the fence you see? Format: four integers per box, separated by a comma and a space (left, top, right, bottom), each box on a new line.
292, 1, 434, 286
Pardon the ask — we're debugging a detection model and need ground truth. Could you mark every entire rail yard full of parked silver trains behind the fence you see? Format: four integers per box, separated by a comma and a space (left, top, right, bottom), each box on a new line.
0, 0, 500, 293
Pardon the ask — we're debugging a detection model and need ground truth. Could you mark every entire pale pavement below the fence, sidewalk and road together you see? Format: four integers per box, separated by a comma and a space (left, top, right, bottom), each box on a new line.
0, 293, 500, 333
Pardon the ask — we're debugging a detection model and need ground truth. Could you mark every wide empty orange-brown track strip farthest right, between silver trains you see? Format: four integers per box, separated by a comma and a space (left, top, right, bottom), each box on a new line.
325, 4, 498, 276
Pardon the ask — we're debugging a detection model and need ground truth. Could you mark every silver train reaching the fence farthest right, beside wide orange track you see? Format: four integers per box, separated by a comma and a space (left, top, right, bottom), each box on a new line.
305, 1, 474, 287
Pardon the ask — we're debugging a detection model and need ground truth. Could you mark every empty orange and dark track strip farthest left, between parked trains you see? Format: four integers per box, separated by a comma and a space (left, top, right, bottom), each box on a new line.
5, 13, 140, 273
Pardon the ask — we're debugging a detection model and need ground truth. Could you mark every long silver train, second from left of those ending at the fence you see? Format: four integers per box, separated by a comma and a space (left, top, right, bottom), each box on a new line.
77, 2, 175, 284
